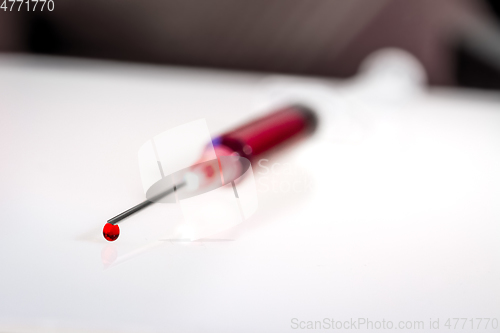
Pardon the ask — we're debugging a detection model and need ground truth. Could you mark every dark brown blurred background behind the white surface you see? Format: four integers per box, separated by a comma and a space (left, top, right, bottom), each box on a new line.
0, 0, 500, 89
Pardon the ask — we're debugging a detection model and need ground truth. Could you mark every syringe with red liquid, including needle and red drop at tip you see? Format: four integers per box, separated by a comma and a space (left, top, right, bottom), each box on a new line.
103, 105, 317, 241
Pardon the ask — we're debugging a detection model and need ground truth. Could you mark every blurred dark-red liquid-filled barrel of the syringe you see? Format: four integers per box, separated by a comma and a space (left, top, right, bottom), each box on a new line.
213, 105, 317, 160
